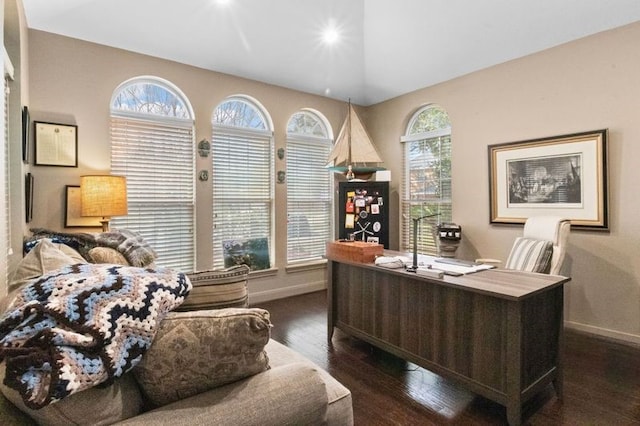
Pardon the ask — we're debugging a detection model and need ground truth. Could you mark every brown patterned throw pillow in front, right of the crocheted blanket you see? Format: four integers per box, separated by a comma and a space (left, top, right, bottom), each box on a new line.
133, 308, 271, 406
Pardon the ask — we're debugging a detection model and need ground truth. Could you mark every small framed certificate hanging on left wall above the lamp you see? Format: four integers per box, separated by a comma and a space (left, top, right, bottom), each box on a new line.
34, 121, 78, 167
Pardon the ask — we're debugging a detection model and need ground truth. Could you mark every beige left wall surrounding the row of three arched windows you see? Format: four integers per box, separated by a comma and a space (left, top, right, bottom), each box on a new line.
29, 31, 346, 301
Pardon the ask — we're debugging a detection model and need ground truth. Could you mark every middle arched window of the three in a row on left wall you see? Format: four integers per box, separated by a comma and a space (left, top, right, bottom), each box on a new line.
211, 96, 274, 269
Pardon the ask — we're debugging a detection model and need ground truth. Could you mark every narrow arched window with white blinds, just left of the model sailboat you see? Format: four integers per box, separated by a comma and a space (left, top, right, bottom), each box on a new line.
286, 110, 332, 264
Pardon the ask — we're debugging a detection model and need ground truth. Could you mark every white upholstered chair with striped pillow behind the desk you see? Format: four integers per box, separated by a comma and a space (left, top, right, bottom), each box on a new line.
477, 216, 571, 275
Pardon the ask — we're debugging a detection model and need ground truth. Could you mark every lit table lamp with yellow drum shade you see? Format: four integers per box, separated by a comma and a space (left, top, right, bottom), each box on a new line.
80, 175, 127, 232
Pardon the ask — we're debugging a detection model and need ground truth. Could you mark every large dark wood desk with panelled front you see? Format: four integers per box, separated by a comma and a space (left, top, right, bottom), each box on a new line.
328, 258, 570, 425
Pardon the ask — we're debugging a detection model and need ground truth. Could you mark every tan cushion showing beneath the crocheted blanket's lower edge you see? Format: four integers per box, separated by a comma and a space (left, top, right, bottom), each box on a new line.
0, 362, 142, 426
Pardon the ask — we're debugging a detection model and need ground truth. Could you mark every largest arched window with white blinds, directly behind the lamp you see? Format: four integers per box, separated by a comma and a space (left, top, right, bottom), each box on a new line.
111, 77, 195, 271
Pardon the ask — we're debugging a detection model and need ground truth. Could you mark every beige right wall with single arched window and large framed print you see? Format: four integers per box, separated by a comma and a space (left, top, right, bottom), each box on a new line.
365, 23, 640, 342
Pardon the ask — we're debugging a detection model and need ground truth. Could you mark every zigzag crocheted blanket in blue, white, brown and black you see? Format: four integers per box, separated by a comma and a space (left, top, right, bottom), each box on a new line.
0, 264, 191, 409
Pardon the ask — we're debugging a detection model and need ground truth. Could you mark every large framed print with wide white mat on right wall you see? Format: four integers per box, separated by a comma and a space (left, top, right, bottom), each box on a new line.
488, 129, 609, 230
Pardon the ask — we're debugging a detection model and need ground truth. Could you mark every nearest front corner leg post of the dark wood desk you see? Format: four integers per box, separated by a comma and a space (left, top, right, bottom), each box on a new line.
507, 303, 522, 426
